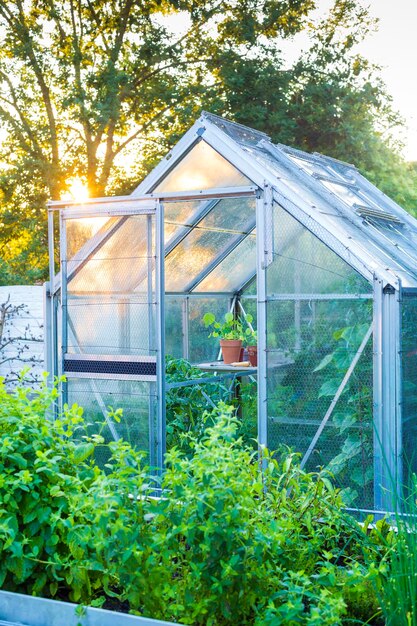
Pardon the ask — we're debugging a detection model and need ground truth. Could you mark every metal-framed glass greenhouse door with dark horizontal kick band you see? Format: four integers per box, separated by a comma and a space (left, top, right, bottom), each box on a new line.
61, 200, 164, 467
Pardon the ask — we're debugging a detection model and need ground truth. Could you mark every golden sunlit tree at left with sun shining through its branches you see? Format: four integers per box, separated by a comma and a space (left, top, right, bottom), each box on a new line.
0, 0, 313, 198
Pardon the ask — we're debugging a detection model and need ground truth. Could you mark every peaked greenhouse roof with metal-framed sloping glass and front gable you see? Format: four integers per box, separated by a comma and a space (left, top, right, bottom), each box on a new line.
132, 112, 417, 287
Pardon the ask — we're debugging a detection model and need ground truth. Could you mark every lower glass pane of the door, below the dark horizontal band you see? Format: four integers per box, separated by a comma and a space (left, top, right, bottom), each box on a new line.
67, 379, 156, 467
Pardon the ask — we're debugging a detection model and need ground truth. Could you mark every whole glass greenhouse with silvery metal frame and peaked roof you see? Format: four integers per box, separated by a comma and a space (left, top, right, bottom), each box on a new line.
46, 113, 417, 511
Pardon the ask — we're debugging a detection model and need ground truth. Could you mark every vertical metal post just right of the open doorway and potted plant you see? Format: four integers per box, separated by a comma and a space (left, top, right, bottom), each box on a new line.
256, 185, 273, 452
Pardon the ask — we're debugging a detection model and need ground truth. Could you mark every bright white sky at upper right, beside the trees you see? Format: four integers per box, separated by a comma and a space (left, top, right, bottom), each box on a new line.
318, 0, 417, 161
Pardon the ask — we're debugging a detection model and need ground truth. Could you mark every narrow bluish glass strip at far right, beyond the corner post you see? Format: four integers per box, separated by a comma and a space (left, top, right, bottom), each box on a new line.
401, 293, 417, 485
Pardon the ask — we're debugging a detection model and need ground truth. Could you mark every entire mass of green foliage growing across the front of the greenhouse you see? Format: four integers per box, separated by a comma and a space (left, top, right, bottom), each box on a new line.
0, 378, 386, 626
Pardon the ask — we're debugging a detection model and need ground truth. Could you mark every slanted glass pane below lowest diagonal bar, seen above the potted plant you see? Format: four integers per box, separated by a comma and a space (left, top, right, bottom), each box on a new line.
195, 231, 256, 293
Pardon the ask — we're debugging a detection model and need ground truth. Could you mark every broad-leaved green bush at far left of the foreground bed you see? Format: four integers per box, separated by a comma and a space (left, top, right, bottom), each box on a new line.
0, 372, 95, 599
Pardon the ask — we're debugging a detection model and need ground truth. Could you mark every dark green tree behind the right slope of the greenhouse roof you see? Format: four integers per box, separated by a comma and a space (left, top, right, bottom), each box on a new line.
220, 1, 417, 213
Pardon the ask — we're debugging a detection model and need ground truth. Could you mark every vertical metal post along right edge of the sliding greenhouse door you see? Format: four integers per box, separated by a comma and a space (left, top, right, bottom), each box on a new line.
155, 200, 166, 471
